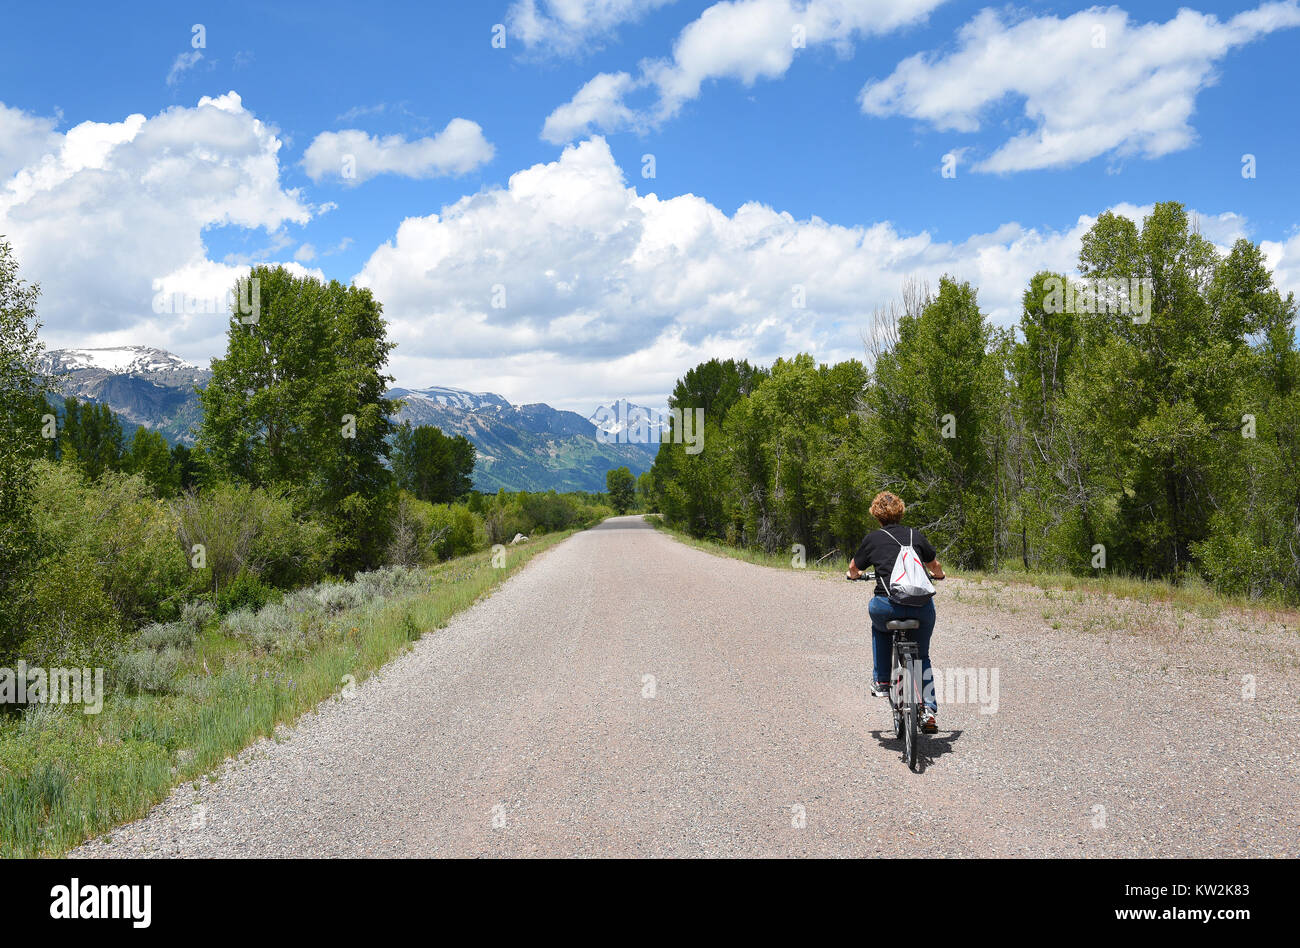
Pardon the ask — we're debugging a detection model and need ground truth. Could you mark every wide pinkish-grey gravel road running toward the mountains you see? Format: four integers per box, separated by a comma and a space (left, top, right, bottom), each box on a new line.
74, 518, 1300, 857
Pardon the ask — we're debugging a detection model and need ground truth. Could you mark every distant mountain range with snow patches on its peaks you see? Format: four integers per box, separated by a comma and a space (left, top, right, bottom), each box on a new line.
44, 346, 659, 492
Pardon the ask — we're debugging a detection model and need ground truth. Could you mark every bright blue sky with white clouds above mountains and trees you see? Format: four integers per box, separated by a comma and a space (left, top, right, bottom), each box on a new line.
0, 0, 1300, 412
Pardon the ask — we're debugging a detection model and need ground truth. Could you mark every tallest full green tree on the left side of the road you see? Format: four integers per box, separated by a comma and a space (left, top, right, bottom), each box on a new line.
199, 267, 397, 572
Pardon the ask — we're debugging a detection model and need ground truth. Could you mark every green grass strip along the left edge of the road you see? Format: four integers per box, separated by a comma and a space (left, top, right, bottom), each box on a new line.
0, 531, 575, 857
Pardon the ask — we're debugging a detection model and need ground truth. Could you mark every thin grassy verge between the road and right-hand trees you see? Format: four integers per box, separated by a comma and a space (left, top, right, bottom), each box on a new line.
646, 515, 1300, 628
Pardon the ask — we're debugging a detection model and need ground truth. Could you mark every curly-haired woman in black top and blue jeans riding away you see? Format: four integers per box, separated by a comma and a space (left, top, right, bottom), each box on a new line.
849, 490, 944, 733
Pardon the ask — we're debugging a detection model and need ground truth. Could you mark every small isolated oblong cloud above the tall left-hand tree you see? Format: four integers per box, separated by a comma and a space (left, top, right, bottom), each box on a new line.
303, 118, 494, 185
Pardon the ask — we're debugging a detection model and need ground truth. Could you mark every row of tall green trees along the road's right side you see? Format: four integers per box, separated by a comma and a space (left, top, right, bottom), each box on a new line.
651, 203, 1300, 602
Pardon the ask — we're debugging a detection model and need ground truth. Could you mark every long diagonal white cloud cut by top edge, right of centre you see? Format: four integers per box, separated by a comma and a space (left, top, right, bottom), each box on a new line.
542, 0, 944, 143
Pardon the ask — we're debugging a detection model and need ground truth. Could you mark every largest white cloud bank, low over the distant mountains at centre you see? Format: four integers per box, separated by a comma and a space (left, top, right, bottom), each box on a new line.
356, 138, 1300, 410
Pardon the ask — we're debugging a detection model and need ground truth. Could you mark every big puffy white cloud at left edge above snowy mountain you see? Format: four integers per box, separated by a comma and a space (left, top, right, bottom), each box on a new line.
0, 92, 311, 359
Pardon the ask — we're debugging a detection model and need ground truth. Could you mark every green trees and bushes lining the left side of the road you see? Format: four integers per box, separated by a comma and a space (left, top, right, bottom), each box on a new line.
0, 248, 612, 667
